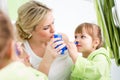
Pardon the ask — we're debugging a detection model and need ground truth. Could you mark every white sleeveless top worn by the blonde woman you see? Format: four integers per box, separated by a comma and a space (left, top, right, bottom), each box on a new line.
24, 41, 73, 80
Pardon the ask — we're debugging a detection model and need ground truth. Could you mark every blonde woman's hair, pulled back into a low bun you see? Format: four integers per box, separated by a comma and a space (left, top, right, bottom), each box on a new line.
16, 1, 51, 40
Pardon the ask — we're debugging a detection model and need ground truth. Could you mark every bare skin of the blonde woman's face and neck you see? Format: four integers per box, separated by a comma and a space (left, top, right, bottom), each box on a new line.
28, 12, 55, 57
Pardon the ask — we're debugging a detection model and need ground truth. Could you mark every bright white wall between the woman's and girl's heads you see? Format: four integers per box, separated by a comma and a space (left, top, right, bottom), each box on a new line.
38, 0, 96, 41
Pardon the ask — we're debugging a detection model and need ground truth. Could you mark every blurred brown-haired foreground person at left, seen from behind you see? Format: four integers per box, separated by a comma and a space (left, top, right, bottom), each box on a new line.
0, 11, 48, 80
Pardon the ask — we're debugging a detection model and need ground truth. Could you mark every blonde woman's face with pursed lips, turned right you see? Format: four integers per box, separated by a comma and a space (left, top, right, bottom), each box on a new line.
31, 12, 55, 42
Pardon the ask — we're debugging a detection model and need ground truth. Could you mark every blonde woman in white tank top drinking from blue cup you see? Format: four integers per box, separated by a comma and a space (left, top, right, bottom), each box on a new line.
16, 1, 72, 80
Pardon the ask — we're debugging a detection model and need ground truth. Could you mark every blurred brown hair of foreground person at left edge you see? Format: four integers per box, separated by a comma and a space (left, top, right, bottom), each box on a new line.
0, 10, 14, 59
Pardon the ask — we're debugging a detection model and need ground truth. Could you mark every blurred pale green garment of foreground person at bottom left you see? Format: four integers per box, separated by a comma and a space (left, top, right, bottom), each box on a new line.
0, 61, 48, 80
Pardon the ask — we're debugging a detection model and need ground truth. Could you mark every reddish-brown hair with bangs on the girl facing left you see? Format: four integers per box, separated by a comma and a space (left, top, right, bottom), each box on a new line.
75, 23, 103, 49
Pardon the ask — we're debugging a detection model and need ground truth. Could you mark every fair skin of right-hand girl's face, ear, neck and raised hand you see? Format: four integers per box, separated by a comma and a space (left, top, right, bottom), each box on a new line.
67, 29, 99, 63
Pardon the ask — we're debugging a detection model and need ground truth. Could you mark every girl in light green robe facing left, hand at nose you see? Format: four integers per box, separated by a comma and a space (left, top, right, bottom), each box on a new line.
67, 23, 111, 80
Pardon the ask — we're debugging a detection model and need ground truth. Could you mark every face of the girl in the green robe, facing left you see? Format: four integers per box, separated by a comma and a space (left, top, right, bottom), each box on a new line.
75, 29, 93, 54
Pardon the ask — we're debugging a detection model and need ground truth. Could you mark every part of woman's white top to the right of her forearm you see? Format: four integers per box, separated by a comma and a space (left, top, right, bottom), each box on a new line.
48, 52, 73, 80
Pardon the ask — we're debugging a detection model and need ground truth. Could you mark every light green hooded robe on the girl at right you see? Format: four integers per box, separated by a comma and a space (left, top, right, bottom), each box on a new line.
71, 48, 111, 80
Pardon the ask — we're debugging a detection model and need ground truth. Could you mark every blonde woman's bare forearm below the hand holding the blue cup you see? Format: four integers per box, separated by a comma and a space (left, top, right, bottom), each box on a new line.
39, 43, 59, 75
